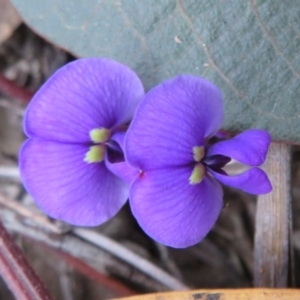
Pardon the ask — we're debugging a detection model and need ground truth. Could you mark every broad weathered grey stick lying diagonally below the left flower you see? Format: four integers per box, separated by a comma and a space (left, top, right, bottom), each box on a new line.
0, 195, 170, 291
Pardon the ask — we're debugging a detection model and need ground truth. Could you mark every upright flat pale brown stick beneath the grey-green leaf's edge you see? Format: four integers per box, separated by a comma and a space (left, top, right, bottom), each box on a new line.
254, 143, 291, 287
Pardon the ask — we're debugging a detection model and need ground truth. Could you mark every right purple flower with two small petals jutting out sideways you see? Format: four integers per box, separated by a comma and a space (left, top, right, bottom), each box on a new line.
125, 75, 272, 248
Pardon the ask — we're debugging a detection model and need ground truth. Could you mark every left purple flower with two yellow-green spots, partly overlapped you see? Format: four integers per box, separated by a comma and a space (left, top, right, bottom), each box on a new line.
20, 58, 144, 226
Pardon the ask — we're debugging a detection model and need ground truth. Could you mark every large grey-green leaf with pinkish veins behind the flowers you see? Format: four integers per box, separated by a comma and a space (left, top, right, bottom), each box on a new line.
12, 0, 300, 143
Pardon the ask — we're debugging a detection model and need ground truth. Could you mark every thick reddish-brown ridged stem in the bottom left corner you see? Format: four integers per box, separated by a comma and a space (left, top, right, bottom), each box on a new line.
0, 222, 52, 300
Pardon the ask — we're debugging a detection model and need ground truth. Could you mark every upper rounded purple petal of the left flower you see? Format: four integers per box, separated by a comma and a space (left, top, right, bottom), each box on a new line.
24, 58, 144, 143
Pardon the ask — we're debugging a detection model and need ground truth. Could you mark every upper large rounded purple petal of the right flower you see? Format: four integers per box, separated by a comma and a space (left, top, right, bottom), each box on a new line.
125, 75, 223, 170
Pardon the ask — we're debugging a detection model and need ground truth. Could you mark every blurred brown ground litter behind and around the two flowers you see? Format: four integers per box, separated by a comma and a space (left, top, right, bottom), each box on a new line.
0, 0, 300, 300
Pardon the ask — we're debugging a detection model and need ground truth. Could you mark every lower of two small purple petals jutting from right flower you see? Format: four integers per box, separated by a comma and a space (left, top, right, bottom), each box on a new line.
209, 167, 272, 195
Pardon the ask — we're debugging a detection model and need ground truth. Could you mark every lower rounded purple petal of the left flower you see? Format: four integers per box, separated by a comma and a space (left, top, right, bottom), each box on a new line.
19, 138, 129, 226
